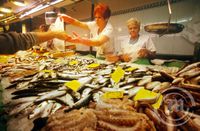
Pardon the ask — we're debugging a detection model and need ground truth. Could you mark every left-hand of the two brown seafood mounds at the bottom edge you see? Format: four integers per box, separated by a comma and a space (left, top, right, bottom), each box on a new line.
42, 108, 97, 131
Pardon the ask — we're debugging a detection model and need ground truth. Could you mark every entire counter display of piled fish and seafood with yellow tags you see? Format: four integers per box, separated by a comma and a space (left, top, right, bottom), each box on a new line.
0, 52, 200, 131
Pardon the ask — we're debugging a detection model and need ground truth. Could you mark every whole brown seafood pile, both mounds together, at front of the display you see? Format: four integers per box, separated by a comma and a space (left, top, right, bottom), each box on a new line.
43, 99, 156, 131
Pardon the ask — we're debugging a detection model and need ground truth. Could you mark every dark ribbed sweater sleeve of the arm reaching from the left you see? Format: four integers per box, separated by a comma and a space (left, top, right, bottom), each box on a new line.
0, 32, 37, 54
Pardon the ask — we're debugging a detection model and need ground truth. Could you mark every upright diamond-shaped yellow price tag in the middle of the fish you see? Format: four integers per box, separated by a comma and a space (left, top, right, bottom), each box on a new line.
111, 66, 125, 83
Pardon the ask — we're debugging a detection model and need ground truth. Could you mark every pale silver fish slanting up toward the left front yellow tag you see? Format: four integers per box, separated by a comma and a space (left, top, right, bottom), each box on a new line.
34, 90, 66, 102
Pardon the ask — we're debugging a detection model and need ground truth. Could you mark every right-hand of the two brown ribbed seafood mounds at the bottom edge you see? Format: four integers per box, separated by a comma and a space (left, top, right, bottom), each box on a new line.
94, 109, 156, 131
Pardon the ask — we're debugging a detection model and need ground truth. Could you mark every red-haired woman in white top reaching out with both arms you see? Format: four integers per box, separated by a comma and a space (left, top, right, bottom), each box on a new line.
59, 3, 115, 58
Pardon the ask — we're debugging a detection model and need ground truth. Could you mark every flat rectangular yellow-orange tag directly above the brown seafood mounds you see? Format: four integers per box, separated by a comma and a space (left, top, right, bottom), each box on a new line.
103, 91, 124, 99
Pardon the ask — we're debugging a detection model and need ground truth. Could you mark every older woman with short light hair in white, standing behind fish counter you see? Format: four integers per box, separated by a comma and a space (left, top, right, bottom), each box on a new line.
120, 18, 156, 62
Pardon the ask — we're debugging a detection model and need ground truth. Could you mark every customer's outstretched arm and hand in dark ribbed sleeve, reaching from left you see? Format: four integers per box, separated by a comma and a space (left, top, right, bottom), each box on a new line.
0, 31, 70, 54
